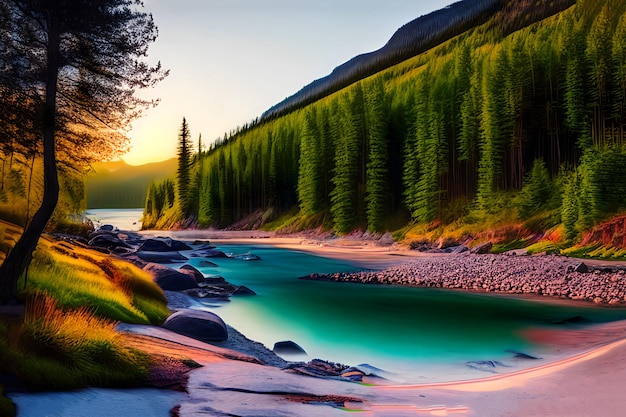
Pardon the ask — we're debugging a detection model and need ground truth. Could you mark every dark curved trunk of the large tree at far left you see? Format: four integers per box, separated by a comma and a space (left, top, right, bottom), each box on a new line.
0, 21, 60, 304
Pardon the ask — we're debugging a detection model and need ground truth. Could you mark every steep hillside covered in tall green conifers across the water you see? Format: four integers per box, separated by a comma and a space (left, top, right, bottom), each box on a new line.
144, 0, 626, 244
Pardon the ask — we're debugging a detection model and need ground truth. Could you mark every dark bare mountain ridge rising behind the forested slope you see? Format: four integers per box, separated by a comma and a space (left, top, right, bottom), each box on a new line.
261, 0, 575, 119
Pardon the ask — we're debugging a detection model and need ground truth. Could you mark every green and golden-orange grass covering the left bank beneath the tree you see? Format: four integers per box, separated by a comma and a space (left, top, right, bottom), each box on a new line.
0, 221, 169, 390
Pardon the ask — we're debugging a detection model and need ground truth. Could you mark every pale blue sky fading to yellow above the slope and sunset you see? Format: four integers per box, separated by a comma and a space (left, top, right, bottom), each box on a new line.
122, 0, 454, 165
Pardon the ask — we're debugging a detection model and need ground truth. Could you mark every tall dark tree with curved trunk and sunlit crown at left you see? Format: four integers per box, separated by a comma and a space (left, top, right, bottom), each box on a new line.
0, 0, 167, 304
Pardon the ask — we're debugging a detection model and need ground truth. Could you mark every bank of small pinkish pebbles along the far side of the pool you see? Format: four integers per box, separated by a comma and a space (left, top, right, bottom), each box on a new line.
302, 253, 626, 305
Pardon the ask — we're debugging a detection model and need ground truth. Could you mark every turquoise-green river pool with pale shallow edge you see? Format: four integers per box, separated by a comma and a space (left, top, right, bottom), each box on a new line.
185, 245, 626, 374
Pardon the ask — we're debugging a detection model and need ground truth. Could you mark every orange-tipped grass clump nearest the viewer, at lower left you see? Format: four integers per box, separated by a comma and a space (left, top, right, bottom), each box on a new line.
0, 293, 149, 389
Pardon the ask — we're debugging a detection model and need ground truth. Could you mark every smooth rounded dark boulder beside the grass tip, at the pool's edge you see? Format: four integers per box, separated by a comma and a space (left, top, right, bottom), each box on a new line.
163, 310, 228, 342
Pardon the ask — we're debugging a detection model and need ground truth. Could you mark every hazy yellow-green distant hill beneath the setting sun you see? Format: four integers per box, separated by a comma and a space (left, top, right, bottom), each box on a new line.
86, 158, 176, 208
